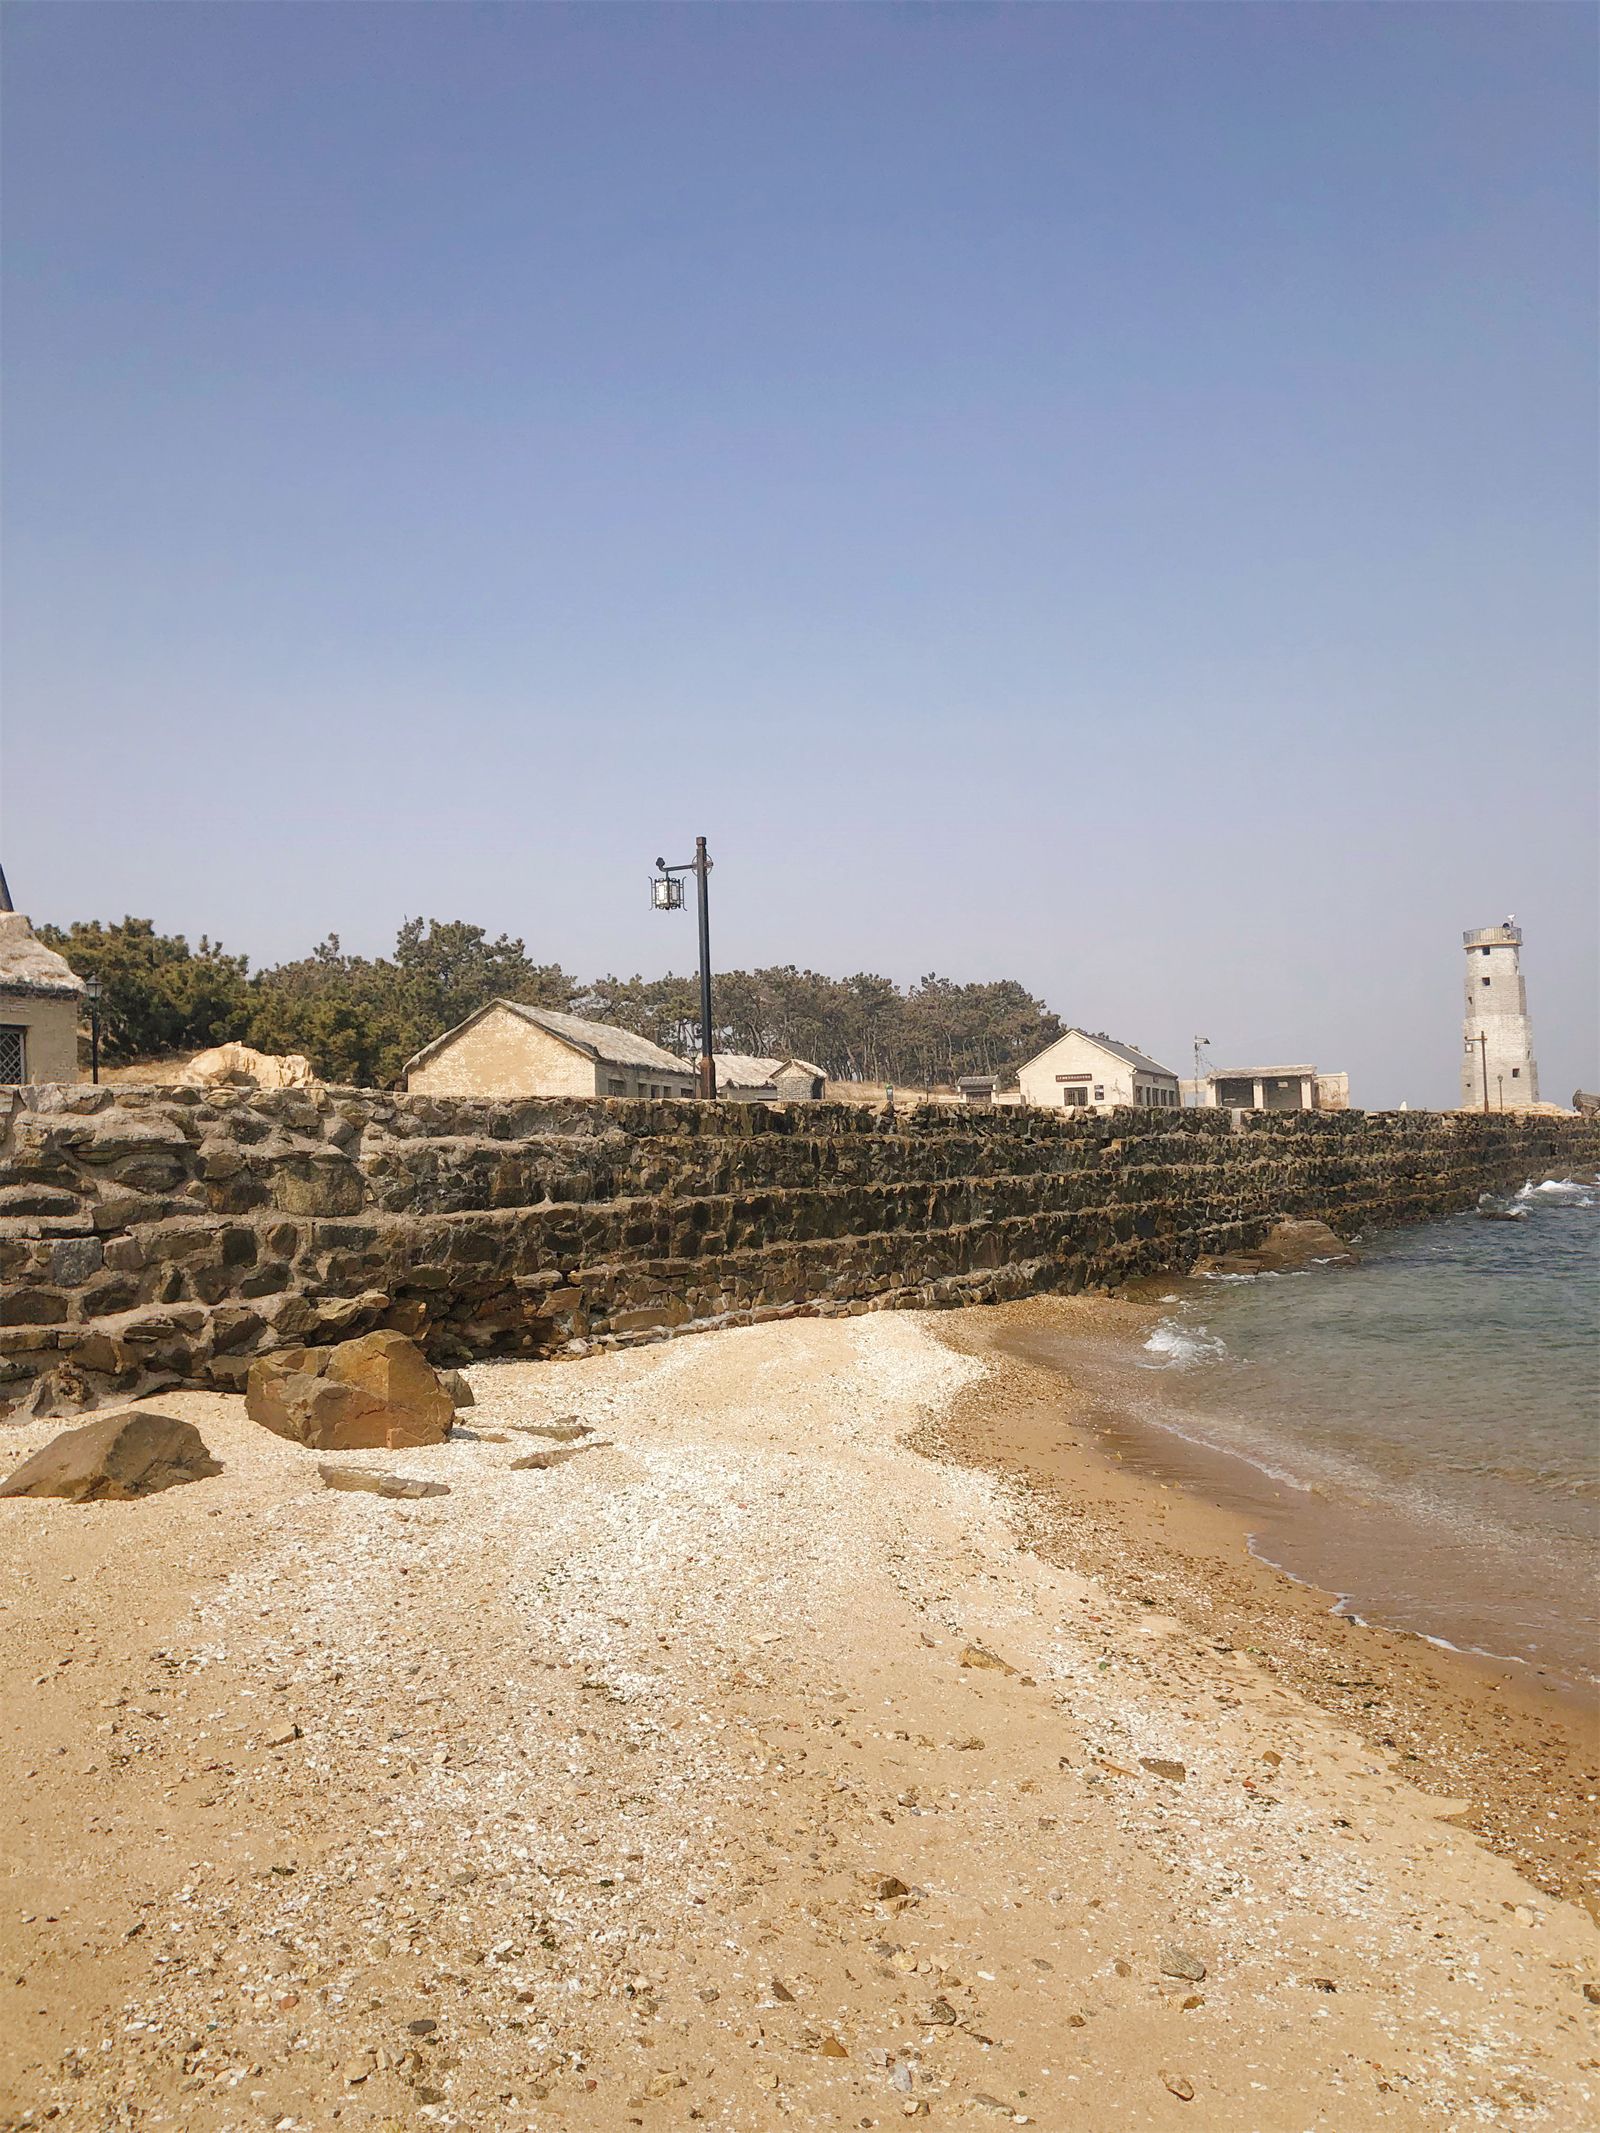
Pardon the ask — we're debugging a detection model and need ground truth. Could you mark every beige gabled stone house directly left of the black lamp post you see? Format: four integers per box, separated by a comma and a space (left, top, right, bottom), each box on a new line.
403, 1000, 695, 1098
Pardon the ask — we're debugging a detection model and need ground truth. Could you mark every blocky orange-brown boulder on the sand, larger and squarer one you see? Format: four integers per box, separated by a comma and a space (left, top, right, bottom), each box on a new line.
245, 1333, 454, 1453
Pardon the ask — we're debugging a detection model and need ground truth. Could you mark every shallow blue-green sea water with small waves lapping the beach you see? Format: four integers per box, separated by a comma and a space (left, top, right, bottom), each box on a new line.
1120, 1180, 1600, 1683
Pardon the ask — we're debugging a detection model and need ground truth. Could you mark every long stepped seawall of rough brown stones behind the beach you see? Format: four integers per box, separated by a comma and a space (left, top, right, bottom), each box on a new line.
0, 1086, 1600, 1412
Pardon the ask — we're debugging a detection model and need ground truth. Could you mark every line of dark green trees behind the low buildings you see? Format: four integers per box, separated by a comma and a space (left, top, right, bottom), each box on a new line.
38, 919, 1062, 1088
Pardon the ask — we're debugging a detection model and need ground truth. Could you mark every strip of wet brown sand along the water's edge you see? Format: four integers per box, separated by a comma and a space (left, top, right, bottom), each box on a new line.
915, 1297, 1600, 1922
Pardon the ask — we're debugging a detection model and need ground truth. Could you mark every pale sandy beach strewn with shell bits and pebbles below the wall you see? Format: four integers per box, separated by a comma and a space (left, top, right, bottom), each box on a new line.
0, 1303, 1600, 2133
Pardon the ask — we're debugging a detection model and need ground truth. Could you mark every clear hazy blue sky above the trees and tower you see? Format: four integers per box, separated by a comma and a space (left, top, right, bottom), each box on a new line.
4, 0, 1600, 1105
